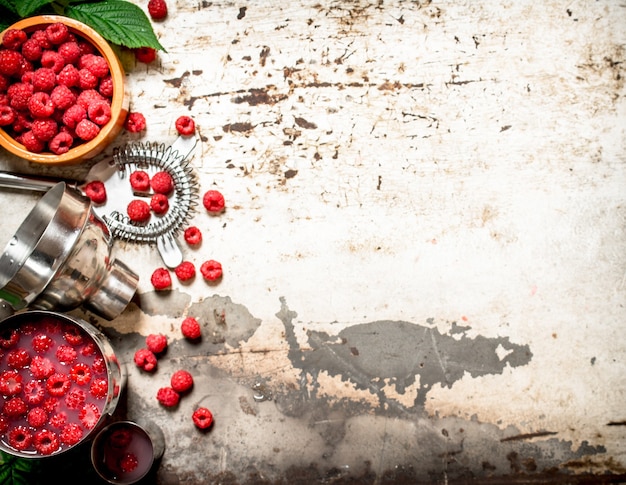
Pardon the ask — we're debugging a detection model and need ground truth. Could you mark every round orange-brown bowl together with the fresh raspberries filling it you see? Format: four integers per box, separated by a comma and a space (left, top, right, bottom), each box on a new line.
0, 15, 128, 165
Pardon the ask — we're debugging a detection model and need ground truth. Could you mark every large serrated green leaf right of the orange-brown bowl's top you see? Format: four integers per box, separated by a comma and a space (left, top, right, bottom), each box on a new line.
65, 0, 165, 51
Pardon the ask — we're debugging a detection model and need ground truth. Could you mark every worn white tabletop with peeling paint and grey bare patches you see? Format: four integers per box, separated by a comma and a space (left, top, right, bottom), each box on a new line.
0, 0, 626, 484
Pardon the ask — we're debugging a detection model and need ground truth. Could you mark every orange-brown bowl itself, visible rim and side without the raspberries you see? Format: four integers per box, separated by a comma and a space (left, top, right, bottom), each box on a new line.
0, 15, 128, 165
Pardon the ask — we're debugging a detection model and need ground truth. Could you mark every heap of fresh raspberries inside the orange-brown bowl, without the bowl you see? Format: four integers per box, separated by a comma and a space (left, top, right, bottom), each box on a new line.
0, 22, 113, 155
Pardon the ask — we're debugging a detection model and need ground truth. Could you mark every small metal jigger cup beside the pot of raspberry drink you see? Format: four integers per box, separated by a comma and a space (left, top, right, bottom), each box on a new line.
91, 420, 165, 485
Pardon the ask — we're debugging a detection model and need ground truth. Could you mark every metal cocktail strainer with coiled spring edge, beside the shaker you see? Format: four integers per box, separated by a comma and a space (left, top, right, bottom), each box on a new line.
0, 136, 198, 268
